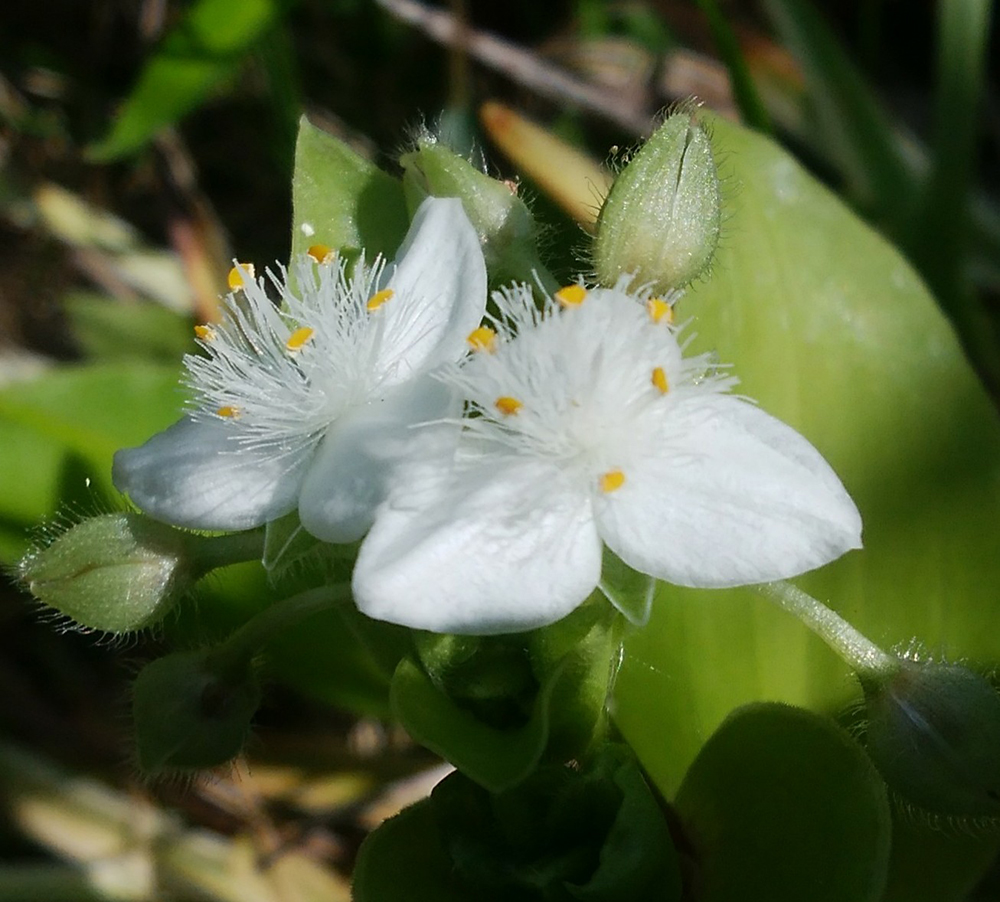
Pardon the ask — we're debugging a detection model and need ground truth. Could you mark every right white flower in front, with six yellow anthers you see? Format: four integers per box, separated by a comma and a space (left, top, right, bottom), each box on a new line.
354, 280, 861, 634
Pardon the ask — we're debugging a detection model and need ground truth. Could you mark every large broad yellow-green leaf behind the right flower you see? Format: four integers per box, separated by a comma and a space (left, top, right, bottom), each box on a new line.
615, 115, 1000, 888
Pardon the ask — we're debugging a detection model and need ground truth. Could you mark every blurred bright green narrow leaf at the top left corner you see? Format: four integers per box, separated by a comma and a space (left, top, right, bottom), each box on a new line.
88, 0, 278, 160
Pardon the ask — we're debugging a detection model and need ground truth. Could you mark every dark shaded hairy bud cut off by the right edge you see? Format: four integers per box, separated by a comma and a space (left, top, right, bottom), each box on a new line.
864, 661, 1000, 817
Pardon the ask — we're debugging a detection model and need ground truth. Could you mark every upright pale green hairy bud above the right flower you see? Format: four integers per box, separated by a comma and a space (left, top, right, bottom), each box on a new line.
593, 112, 720, 292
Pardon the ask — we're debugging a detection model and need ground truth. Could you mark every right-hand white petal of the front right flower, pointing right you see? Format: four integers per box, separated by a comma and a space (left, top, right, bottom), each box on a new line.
595, 395, 861, 588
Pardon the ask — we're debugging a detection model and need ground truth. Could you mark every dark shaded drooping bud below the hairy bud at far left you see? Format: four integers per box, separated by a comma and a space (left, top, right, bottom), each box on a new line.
132, 650, 260, 775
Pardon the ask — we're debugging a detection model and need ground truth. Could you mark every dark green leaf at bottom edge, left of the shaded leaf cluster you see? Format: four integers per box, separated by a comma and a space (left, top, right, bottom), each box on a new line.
352, 799, 470, 902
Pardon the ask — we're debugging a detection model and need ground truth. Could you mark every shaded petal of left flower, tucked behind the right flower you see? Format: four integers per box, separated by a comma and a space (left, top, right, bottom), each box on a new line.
299, 375, 461, 542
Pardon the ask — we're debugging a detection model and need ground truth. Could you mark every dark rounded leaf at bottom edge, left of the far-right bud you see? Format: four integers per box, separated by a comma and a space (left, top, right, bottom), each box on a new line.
675, 704, 891, 902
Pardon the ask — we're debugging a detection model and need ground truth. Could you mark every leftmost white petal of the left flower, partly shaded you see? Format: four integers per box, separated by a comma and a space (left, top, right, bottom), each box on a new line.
111, 417, 309, 529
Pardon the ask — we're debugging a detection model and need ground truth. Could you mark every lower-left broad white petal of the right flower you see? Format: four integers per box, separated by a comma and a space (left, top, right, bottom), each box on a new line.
354, 459, 601, 635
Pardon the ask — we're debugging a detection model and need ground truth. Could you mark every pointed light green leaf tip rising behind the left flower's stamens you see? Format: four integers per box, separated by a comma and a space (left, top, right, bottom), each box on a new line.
292, 116, 410, 261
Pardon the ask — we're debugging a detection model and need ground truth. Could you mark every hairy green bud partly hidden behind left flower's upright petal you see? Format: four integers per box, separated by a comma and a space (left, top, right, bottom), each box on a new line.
399, 134, 544, 284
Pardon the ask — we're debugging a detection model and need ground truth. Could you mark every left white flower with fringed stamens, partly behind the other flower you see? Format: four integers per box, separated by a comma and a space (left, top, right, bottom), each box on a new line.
113, 198, 486, 542
